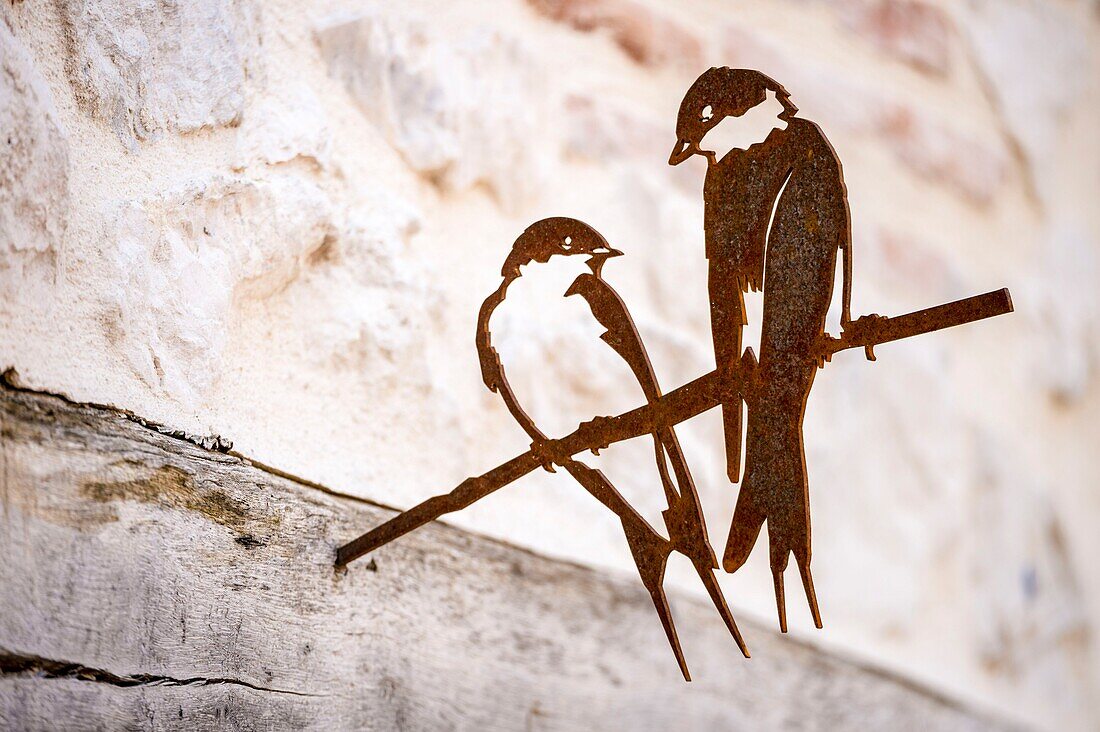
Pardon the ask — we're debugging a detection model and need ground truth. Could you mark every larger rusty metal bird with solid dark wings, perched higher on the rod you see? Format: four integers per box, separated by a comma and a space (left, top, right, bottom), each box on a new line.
669, 67, 851, 632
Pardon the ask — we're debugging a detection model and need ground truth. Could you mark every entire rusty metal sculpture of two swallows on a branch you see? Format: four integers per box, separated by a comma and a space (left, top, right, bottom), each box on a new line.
337, 68, 1012, 679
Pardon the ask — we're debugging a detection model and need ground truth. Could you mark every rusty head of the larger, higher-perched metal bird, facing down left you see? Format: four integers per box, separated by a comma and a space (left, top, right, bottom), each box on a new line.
669, 66, 799, 165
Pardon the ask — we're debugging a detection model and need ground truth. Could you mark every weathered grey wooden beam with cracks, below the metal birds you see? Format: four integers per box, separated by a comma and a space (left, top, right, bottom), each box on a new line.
0, 389, 1003, 730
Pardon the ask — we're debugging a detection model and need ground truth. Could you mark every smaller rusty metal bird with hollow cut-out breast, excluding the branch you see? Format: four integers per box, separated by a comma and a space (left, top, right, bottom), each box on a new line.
476, 217, 749, 680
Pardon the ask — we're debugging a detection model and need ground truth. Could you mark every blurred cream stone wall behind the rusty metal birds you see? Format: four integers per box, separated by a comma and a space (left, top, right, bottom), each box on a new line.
0, 0, 1100, 729
